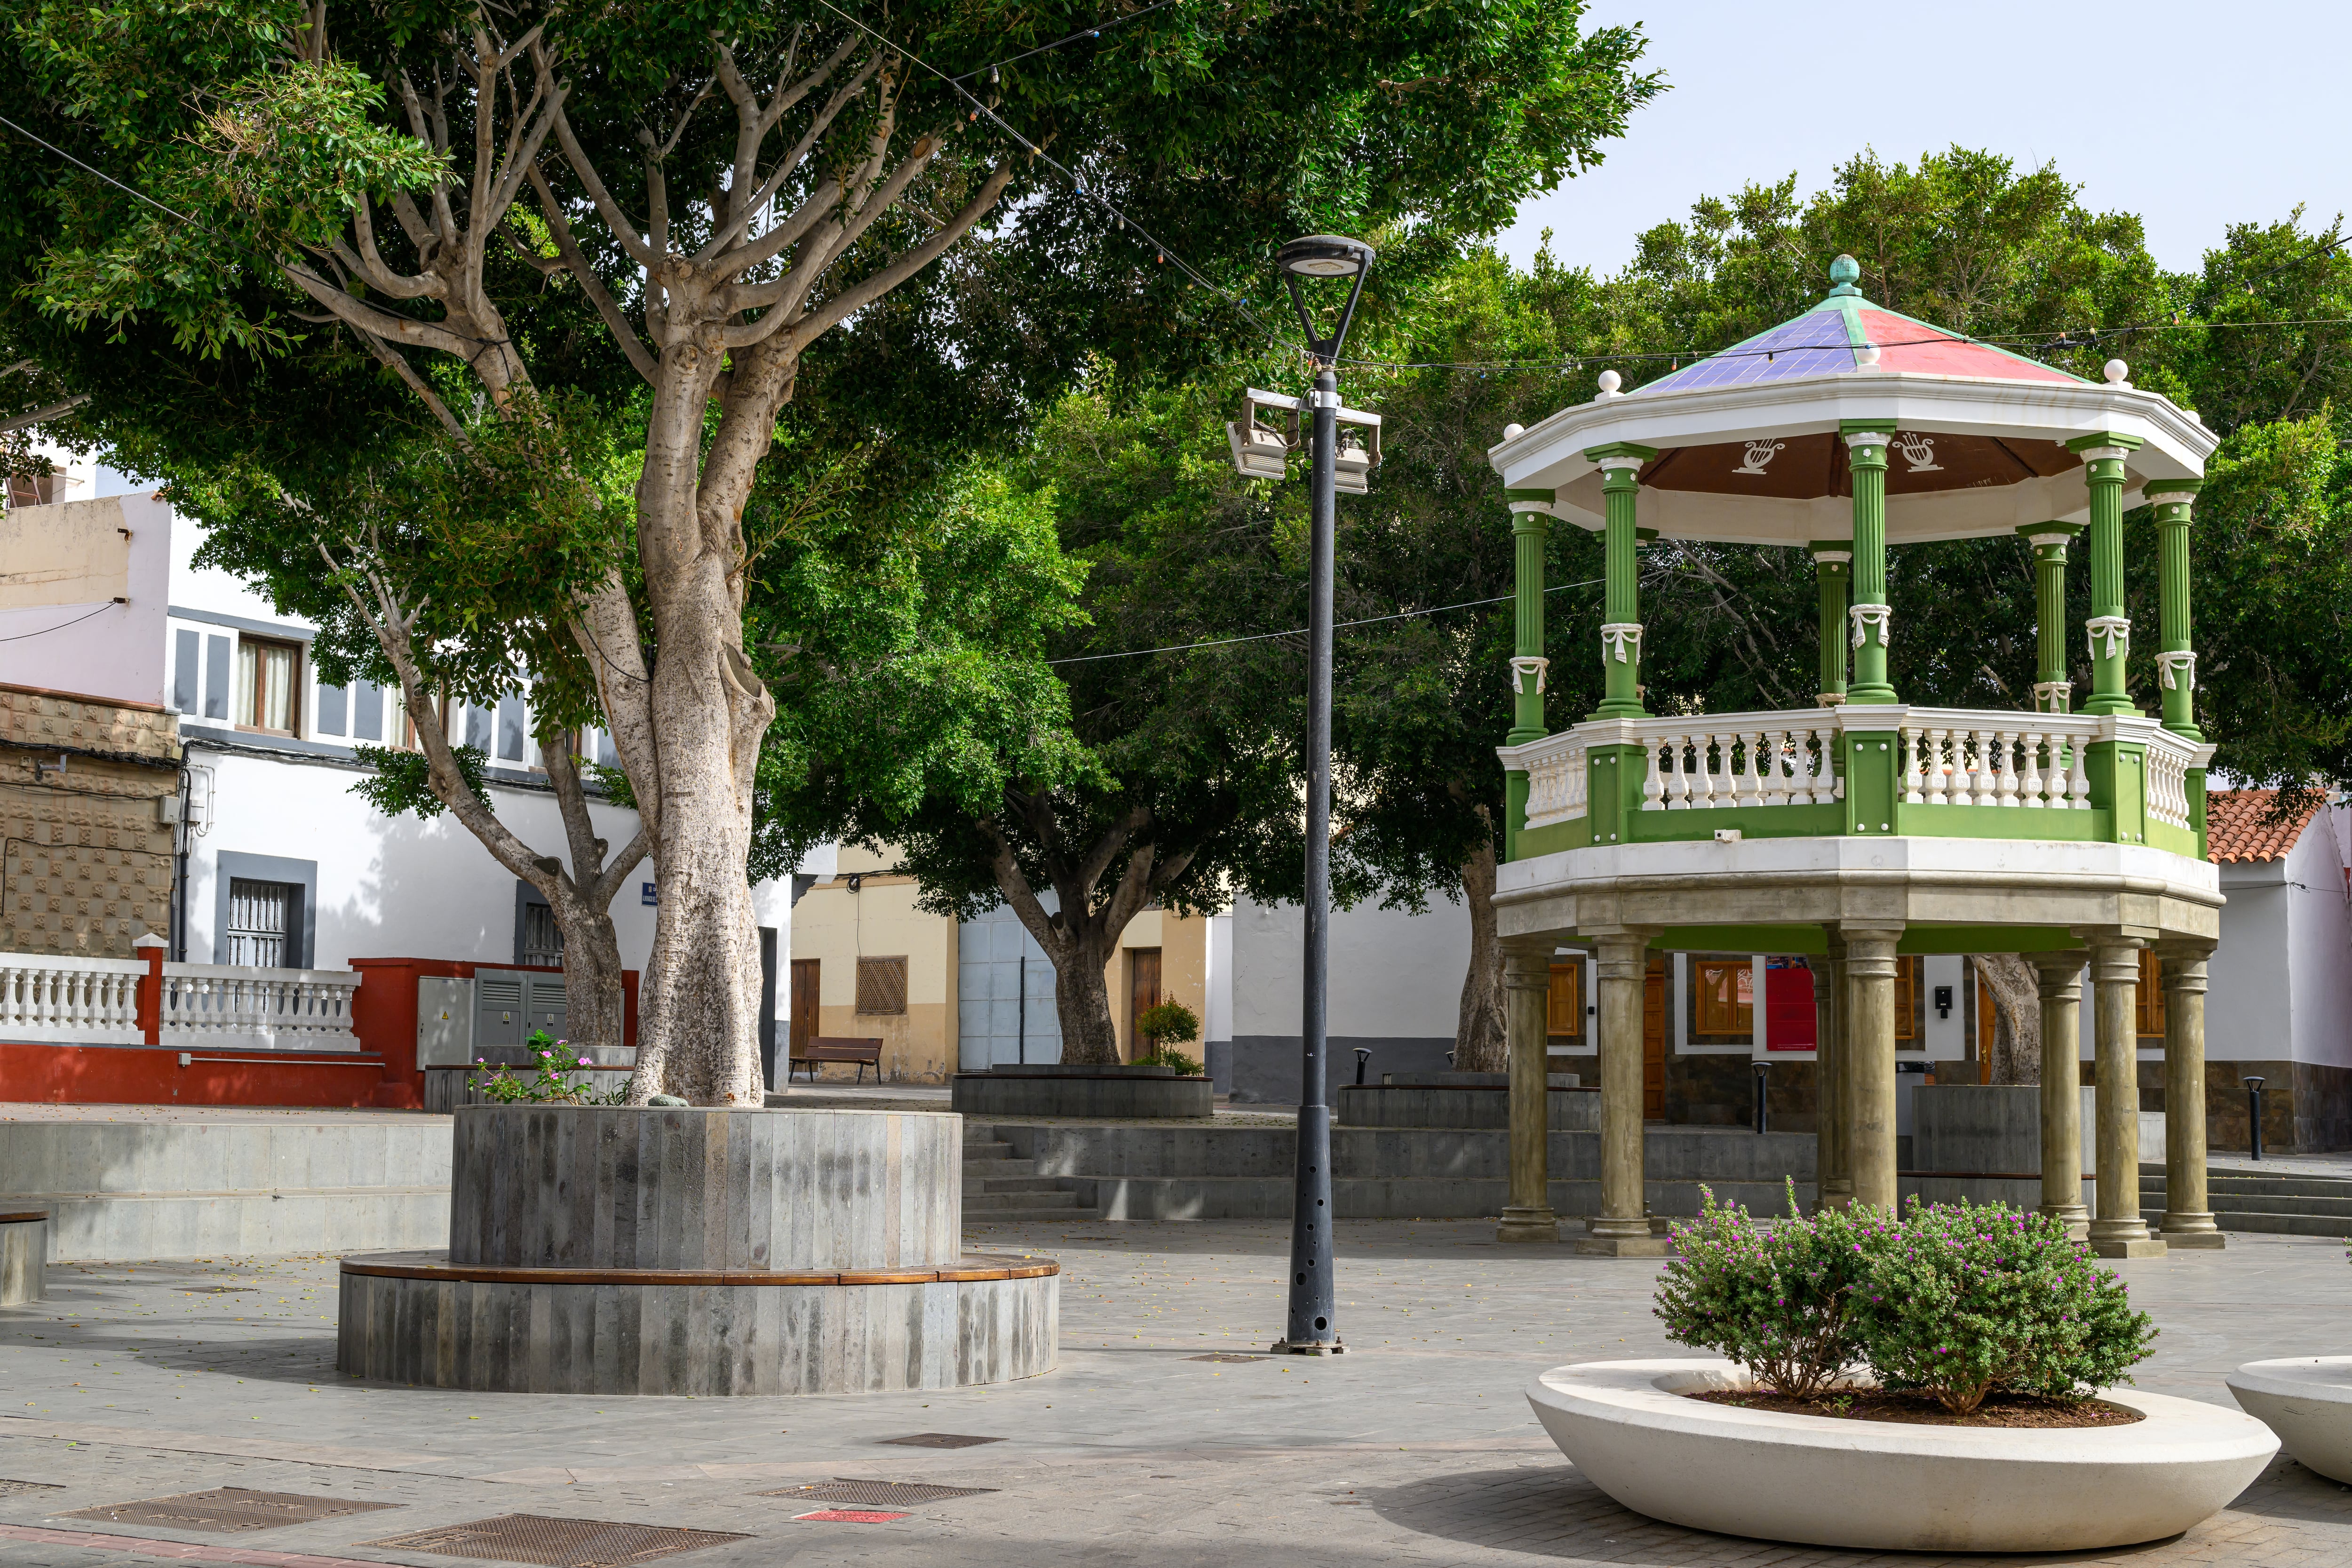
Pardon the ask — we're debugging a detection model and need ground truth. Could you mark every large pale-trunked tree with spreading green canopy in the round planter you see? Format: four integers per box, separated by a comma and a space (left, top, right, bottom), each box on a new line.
12, 0, 1653, 1103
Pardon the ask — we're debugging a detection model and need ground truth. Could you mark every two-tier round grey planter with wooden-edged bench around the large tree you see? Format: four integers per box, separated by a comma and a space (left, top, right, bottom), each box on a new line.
336, 1105, 1061, 1394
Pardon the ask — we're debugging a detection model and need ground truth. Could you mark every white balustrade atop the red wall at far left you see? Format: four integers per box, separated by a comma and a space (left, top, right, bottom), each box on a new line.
0, 952, 360, 1051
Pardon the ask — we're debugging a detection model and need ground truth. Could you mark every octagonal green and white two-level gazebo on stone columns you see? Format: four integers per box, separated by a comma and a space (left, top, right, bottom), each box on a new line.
1489, 256, 2223, 1258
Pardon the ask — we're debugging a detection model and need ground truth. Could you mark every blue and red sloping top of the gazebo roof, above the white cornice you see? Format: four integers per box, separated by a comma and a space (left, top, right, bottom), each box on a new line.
1637, 256, 2091, 395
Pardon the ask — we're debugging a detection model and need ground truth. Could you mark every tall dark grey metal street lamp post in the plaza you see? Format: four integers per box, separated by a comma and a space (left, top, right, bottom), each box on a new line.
1275, 235, 1371, 1356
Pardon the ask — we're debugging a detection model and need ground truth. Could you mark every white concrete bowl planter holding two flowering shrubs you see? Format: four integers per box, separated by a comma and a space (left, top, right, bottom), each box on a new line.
1526, 1359, 2279, 1552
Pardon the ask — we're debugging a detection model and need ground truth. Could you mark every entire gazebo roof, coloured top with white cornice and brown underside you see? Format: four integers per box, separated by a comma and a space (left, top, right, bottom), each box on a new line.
1486, 256, 2216, 545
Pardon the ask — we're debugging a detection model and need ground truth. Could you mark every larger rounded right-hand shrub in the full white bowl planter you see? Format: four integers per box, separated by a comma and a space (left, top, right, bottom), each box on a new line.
1856, 1199, 2157, 1415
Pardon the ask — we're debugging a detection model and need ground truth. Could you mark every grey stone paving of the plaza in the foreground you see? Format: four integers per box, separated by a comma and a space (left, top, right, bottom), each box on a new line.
0, 1220, 2352, 1568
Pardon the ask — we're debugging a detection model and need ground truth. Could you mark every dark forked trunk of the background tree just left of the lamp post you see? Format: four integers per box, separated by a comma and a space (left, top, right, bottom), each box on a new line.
981, 790, 1195, 1067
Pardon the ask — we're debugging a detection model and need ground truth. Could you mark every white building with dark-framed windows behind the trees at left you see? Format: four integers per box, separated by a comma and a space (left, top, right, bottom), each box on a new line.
0, 458, 793, 1079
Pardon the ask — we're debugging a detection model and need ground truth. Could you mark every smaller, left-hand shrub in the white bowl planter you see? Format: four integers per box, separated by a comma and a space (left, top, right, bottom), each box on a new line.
1653, 1182, 1889, 1399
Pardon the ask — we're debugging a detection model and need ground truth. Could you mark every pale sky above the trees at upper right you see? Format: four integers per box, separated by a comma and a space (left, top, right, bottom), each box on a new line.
1501, 0, 2352, 273
